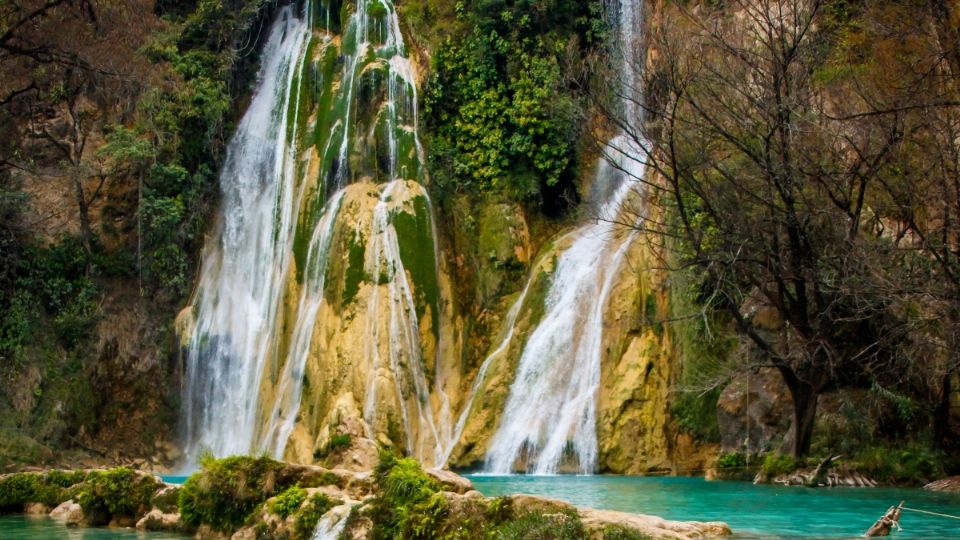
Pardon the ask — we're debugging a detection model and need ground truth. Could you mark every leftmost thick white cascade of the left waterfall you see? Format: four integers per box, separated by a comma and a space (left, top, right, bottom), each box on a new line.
181, 6, 309, 466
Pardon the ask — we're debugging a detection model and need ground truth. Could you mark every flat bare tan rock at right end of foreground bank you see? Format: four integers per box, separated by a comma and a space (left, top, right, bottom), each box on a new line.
579, 508, 733, 540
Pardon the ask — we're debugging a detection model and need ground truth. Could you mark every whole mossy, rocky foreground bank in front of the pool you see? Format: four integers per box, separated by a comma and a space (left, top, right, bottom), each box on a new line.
0, 456, 731, 540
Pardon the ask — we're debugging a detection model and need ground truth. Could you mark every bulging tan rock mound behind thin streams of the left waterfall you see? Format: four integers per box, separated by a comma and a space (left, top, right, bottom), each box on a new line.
251, 181, 464, 470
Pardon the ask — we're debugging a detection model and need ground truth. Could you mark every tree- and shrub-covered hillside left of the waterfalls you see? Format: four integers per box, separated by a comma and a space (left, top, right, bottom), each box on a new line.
0, 0, 273, 466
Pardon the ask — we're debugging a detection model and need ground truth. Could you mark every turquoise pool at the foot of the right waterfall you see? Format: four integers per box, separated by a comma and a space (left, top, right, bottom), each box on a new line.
470, 475, 960, 539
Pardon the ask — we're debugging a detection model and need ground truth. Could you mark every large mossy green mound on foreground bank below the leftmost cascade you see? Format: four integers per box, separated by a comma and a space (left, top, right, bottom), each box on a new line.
178, 456, 289, 532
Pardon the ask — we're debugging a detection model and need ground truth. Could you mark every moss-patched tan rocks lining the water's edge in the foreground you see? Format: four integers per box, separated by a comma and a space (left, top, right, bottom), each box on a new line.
0, 458, 732, 540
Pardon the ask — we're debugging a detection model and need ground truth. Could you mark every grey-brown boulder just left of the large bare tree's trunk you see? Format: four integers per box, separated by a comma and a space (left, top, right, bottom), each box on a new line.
717, 368, 792, 454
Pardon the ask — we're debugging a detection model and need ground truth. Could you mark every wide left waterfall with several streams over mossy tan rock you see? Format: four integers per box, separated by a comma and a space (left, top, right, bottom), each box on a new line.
181, 0, 452, 468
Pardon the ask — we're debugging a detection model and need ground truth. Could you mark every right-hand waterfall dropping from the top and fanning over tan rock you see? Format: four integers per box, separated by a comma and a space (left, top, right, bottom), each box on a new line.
485, 0, 643, 474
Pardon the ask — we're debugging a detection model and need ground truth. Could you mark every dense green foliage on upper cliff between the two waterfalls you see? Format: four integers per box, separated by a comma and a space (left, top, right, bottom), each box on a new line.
425, 0, 604, 206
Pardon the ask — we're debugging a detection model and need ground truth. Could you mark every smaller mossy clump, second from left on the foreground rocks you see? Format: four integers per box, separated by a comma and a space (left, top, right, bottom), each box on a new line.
77, 467, 161, 517
